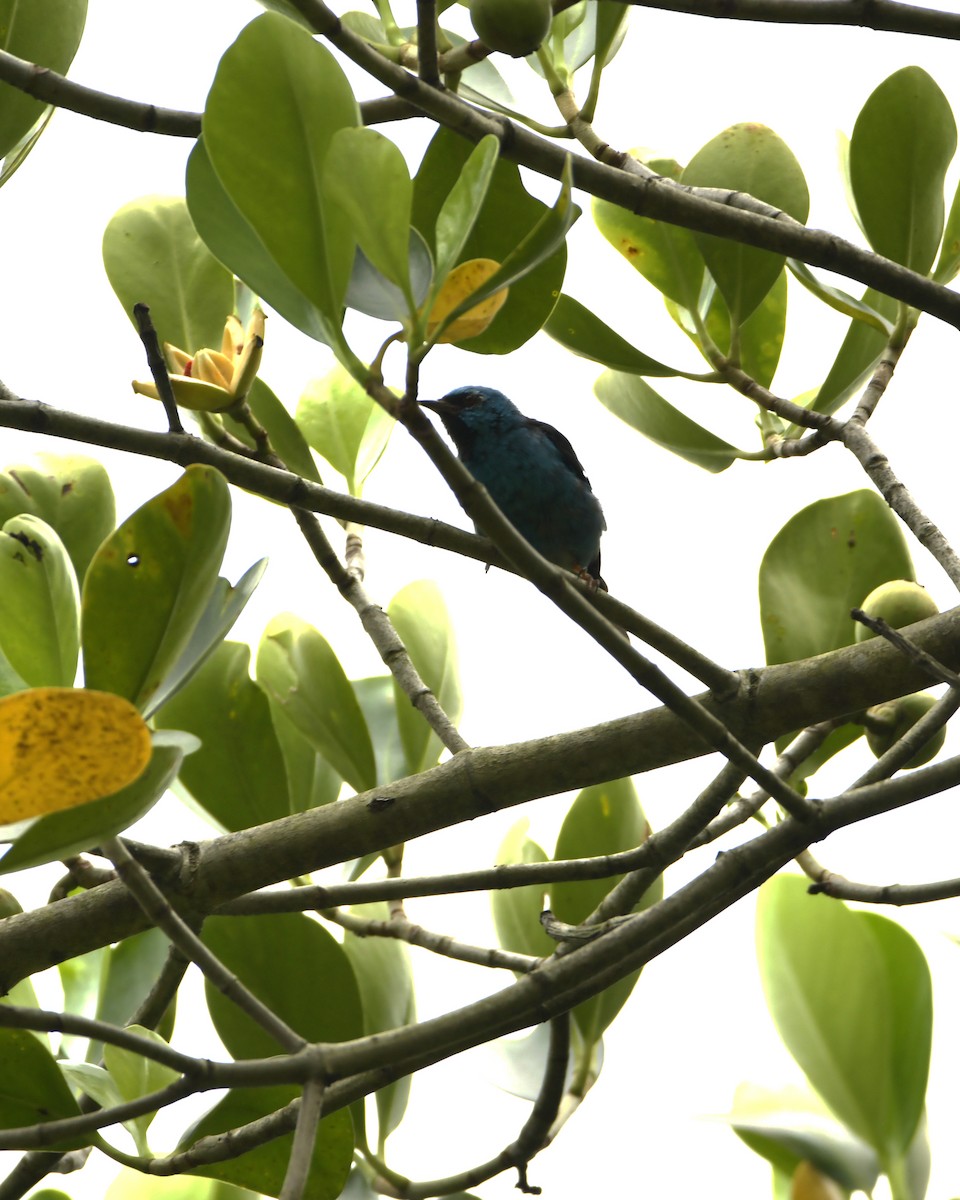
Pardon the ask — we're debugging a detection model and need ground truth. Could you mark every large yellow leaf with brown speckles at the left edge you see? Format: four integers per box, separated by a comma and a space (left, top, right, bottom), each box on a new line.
0, 688, 151, 824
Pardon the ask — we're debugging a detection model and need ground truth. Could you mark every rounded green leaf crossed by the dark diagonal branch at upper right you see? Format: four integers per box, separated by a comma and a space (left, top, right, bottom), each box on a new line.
682, 122, 810, 325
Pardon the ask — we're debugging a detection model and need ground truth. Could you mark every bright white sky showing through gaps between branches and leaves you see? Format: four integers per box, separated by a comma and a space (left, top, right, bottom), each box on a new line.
0, 0, 960, 1200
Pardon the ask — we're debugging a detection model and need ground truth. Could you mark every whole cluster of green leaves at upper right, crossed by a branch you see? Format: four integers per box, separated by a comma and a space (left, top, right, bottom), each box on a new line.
546, 67, 960, 472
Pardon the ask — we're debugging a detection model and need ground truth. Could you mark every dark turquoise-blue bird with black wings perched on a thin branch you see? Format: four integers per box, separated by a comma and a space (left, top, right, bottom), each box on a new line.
420, 386, 607, 592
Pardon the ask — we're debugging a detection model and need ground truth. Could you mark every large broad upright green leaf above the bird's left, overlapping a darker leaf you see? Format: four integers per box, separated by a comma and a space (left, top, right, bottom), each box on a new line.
203, 13, 360, 335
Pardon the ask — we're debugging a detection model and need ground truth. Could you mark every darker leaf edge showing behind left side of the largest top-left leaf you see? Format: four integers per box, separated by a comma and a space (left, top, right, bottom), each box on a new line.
186, 137, 334, 349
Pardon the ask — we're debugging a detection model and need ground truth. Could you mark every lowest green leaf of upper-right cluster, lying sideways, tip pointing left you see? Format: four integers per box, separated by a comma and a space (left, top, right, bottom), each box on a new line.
594, 371, 740, 473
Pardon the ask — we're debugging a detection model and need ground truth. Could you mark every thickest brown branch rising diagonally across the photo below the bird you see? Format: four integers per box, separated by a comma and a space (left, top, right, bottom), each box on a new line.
0, 608, 960, 990
